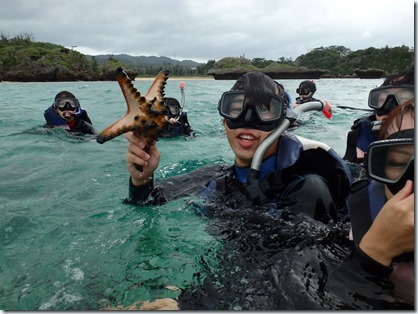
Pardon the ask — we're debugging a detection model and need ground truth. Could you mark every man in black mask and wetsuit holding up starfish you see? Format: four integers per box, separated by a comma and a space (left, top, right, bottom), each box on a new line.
125, 72, 351, 223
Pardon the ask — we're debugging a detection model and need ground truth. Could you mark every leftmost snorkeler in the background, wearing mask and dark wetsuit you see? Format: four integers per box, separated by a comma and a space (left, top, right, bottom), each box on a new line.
44, 91, 97, 135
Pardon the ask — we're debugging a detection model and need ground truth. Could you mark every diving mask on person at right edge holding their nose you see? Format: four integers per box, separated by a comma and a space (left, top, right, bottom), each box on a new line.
365, 137, 415, 194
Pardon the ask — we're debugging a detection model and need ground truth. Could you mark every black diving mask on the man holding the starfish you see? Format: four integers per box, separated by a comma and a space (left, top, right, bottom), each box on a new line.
218, 91, 286, 131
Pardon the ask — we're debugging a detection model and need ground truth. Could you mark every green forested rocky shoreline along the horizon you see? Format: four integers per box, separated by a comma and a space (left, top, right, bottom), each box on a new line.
0, 34, 415, 82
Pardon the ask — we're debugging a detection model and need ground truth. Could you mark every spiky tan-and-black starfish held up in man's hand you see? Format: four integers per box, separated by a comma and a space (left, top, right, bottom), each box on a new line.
96, 67, 169, 147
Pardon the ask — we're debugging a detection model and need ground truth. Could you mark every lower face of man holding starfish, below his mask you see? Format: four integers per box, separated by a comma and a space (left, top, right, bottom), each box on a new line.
223, 119, 277, 167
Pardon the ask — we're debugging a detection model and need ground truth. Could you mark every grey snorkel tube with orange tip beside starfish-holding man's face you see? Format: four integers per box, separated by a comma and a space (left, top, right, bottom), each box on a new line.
246, 101, 332, 203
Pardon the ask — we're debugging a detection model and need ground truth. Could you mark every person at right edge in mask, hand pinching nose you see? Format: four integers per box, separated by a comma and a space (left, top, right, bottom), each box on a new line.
349, 99, 415, 305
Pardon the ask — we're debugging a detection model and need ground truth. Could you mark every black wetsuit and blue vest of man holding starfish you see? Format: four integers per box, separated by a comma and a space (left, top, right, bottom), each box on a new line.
128, 134, 351, 222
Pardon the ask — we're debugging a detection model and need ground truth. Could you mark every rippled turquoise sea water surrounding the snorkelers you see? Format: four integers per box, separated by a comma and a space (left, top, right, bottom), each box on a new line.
0, 79, 382, 310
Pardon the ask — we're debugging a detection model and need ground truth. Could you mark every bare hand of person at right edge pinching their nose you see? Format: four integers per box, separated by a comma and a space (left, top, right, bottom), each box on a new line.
359, 181, 414, 267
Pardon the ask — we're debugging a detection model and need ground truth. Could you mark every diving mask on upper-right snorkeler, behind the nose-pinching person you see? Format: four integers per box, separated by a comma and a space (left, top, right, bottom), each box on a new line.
368, 85, 415, 116
